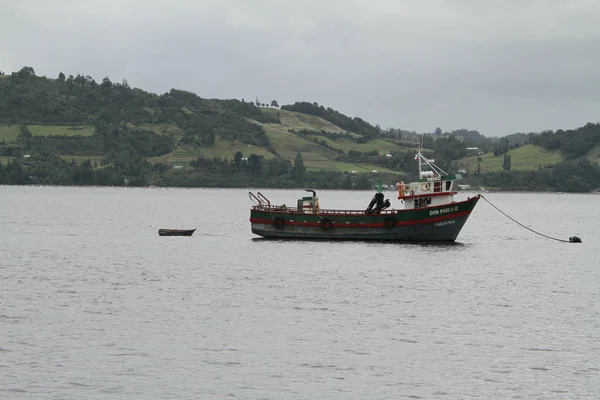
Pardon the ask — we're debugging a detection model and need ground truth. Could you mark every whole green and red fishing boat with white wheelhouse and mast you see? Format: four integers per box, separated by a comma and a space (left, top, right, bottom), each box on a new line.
249, 148, 481, 242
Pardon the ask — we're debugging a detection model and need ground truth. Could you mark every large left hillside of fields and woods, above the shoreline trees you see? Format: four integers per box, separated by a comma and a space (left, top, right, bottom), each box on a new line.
0, 68, 409, 174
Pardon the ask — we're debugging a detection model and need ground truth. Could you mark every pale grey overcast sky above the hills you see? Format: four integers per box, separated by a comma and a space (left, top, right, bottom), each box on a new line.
0, 0, 600, 136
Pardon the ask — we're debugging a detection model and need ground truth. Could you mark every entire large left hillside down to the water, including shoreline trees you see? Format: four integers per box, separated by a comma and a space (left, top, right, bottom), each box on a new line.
0, 67, 414, 187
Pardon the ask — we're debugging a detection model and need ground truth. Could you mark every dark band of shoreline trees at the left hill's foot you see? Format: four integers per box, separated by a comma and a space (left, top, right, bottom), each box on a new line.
0, 152, 397, 190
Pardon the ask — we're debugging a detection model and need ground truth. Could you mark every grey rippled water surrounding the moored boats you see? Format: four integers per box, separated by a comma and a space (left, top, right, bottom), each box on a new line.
0, 187, 600, 400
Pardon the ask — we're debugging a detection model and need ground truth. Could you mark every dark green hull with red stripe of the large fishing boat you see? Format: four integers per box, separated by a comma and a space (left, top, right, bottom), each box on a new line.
250, 195, 479, 242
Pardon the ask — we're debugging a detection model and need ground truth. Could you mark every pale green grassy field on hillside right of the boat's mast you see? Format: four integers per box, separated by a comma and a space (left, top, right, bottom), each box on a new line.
457, 144, 564, 173
